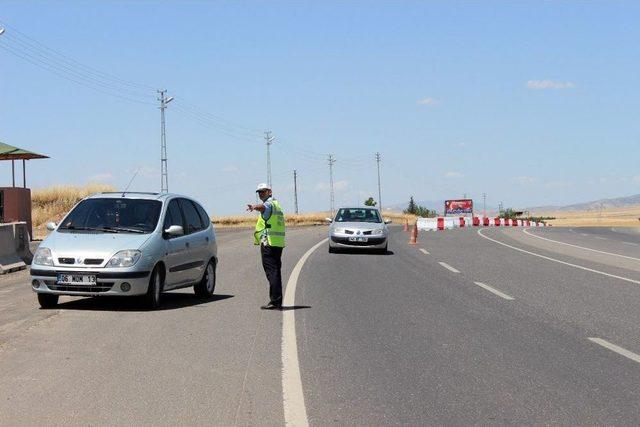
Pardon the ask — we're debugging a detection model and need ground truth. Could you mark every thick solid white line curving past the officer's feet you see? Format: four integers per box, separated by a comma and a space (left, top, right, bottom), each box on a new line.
282, 239, 329, 426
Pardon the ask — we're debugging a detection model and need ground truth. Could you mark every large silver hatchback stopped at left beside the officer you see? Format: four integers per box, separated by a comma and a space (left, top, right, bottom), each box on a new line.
31, 192, 218, 309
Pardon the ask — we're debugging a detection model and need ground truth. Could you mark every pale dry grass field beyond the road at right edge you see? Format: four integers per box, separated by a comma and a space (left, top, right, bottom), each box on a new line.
532, 206, 640, 227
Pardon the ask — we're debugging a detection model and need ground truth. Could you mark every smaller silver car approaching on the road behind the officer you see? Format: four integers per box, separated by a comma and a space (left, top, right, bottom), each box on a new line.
327, 207, 390, 254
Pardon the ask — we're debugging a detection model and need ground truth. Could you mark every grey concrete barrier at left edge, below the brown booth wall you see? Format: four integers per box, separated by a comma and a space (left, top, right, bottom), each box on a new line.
0, 222, 33, 274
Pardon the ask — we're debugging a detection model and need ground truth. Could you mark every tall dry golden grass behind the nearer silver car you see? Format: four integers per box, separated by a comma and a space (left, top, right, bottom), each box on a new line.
31, 184, 115, 239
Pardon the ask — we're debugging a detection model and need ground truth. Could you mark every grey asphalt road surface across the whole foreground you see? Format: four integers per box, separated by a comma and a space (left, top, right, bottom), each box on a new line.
0, 227, 640, 425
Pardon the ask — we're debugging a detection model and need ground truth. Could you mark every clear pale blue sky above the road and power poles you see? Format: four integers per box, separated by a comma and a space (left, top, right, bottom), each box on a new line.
0, 1, 640, 215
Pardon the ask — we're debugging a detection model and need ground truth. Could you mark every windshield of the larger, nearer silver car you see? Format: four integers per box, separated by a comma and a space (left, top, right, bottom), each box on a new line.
58, 198, 162, 233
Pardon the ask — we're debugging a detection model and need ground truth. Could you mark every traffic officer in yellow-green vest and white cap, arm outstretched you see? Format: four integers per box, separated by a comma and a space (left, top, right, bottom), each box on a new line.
247, 183, 285, 310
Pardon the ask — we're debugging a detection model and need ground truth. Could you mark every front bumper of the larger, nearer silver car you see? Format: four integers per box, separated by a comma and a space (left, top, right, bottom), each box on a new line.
30, 266, 150, 296
